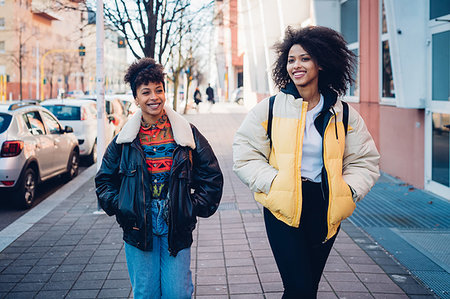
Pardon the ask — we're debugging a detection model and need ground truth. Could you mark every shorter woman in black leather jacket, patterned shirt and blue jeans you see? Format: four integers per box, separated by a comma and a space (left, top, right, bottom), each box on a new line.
95, 58, 223, 299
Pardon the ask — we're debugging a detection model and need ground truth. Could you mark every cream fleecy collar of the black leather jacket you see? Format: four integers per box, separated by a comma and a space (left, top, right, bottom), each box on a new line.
116, 106, 195, 149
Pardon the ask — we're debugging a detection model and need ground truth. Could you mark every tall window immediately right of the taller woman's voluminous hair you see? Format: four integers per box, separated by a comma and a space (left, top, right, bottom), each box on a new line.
341, 0, 359, 101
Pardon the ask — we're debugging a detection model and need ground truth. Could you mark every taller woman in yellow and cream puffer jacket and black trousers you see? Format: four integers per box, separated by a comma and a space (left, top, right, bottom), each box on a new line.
233, 26, 379, 299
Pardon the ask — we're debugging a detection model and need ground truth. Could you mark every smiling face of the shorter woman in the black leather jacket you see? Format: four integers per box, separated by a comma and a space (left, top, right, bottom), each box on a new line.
136, 82, 166, 124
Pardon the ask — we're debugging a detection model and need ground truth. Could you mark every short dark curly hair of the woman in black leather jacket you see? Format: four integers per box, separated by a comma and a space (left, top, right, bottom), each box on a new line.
124, 57, 165, 98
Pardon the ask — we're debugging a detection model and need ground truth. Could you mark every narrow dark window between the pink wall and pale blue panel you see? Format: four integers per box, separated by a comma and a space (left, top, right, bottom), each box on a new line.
381, 1, 395, 102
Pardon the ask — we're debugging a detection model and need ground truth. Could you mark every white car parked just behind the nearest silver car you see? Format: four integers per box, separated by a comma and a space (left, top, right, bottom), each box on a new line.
41, 99, 115, 163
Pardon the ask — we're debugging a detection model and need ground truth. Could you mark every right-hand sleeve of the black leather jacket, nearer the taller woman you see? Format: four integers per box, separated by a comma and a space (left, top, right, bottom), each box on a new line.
191, 126, 223, 217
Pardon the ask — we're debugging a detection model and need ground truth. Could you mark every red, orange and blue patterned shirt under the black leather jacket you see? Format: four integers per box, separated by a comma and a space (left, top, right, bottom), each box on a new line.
139, 113, 176, 200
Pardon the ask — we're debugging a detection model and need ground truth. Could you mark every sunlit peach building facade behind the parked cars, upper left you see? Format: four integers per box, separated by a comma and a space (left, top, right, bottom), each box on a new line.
0, 0, 127, 100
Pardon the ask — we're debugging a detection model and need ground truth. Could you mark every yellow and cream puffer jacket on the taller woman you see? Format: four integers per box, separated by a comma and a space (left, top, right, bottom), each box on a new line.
233, 85, 380, 241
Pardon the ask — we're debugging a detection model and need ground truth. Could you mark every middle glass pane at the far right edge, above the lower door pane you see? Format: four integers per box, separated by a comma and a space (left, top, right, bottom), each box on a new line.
431, 31, 450, 101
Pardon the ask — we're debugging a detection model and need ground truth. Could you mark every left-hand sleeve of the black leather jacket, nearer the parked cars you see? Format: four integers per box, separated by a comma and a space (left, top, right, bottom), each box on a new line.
95, 136, 122, 216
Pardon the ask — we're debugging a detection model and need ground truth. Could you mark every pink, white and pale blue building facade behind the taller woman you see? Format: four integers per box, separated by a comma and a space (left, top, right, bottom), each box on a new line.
238, 0, 450, 200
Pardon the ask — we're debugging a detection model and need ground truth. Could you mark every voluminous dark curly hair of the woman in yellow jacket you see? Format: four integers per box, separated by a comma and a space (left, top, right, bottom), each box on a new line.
272, 26, 356, 95
